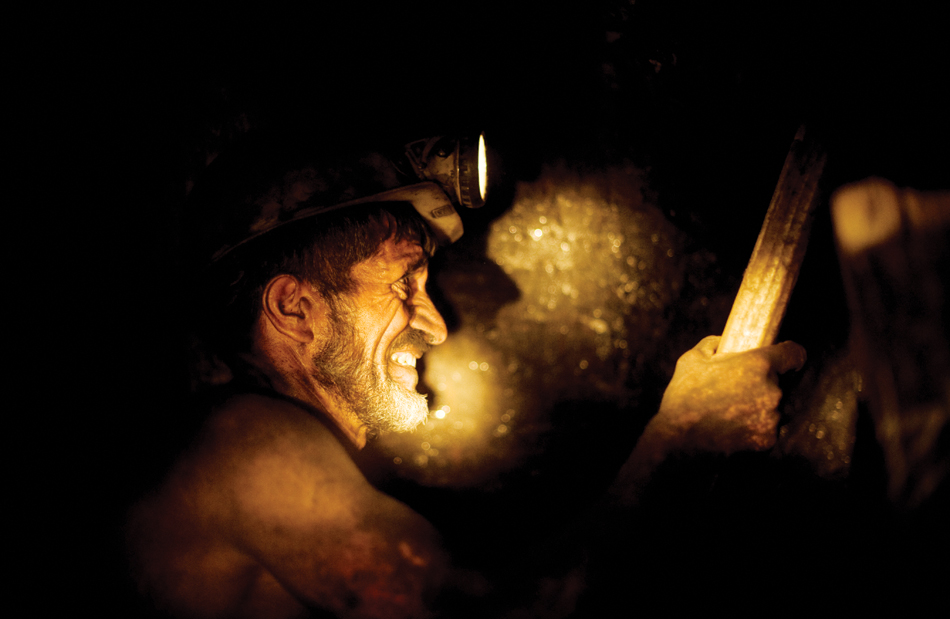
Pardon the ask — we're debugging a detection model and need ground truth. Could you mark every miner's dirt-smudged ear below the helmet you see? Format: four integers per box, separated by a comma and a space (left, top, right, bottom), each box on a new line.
262, 274, 325, 344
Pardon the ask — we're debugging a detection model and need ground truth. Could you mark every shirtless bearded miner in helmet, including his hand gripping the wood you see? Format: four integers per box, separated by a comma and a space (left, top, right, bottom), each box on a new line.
128, 132, 804, 618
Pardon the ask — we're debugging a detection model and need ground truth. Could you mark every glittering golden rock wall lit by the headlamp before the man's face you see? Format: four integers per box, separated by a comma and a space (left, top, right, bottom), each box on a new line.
375, 167, 724, 487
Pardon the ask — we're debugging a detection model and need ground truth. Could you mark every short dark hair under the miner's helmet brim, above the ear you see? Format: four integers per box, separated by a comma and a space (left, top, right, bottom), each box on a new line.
198, 202, 437, 362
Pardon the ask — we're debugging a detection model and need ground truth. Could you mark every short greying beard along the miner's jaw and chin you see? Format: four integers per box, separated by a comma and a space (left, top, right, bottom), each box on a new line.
312, 310, 429, 432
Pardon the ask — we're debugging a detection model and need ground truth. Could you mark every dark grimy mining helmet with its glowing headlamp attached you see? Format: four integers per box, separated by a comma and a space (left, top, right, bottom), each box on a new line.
189, 133, 488, 265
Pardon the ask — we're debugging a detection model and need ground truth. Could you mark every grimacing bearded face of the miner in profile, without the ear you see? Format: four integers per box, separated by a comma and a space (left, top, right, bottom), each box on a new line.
313, 238, 446, 432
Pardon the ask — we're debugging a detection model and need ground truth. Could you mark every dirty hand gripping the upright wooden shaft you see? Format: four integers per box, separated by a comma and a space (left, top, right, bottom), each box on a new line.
651, 336, 805, 454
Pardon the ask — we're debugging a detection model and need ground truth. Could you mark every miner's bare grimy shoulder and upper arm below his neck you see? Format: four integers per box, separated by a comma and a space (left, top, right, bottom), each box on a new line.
128, 394, 447, 617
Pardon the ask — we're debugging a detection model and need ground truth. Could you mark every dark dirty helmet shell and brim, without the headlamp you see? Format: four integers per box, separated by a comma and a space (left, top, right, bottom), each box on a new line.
186, 132, 470, 266
